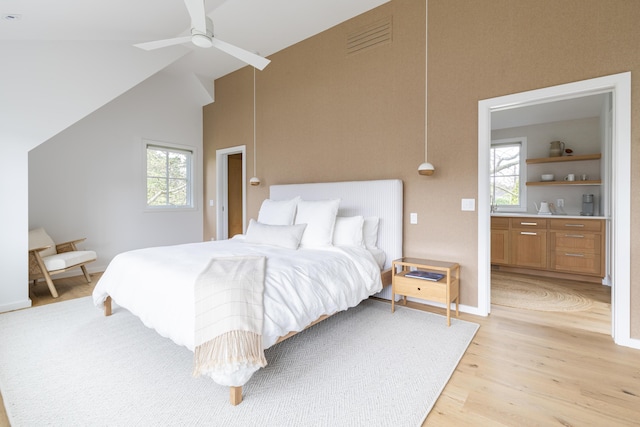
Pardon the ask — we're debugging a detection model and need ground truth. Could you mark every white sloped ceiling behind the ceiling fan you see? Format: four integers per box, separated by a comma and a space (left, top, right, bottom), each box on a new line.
0, 0, 389, 149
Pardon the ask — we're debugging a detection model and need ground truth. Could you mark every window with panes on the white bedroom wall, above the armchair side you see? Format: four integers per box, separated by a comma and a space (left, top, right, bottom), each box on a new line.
145, 143, 194, 209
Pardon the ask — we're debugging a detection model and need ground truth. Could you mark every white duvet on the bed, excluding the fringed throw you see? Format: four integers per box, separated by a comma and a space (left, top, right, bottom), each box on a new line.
93, 236, 382, 385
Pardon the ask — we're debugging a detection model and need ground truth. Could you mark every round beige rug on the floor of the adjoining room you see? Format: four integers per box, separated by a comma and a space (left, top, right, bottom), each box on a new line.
491, 272, 593, 311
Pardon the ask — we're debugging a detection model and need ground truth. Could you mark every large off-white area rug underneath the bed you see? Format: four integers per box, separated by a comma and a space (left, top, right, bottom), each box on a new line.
0, 297, 478, 427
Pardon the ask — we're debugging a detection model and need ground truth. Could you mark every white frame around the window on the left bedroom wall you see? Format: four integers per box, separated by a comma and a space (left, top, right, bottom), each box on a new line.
142, 139, 197, 212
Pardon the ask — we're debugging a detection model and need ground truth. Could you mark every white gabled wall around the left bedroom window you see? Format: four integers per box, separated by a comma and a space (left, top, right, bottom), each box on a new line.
29, 73, 203, 271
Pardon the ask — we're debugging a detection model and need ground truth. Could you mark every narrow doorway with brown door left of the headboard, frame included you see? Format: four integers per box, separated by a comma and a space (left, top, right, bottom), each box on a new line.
216, 145, 247, 240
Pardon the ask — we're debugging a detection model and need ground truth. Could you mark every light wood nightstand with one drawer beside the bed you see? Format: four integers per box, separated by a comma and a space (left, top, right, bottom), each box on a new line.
391, 258, 460, 326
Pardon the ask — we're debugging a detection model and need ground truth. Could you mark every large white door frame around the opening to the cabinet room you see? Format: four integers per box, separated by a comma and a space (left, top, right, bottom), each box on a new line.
478, 72, 640, 349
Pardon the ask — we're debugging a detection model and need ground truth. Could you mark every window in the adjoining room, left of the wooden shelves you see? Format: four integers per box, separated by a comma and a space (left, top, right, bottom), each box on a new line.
489, 138, 527, 211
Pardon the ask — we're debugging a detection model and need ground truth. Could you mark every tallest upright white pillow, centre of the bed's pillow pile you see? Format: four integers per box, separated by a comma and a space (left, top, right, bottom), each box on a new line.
295, 199, 340, 248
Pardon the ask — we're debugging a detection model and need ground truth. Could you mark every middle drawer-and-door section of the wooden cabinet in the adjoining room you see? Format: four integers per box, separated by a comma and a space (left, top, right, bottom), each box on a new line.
510, 218, 547, 268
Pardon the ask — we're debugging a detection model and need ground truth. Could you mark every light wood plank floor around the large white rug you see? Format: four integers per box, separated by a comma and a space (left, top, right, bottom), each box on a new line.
0, 275, 640, 427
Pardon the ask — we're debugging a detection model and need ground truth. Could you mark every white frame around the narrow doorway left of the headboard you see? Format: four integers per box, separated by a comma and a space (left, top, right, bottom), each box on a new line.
216, 145, 247, 240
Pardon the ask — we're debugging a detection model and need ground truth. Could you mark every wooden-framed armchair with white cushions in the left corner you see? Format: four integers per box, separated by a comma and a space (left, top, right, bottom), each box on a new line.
29, 228, 97, 298
